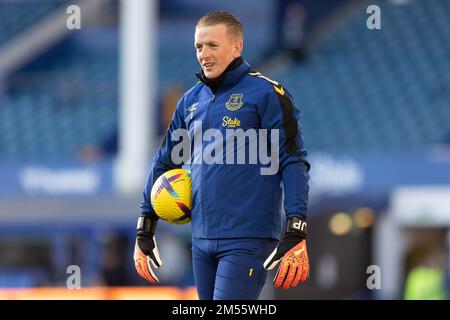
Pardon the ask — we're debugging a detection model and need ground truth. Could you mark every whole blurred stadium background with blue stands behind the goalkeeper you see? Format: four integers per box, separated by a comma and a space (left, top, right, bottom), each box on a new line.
0, 0, 450, 299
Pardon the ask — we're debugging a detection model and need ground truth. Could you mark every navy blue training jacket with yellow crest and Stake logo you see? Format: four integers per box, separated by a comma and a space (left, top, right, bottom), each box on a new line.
141, 61, 310, 239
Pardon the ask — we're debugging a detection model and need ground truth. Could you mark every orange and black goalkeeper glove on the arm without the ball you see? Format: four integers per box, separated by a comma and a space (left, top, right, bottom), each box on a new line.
264, 217, 309, 289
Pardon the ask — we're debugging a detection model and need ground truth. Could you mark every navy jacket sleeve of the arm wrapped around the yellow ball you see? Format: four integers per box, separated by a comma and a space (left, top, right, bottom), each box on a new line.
140, 97, 186, 214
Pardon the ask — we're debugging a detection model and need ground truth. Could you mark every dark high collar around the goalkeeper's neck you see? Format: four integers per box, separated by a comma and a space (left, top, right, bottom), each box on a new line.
196, 57, 250, 93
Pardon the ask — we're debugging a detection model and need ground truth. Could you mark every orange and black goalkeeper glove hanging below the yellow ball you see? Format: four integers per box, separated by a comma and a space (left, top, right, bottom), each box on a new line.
134, 214, 162, 284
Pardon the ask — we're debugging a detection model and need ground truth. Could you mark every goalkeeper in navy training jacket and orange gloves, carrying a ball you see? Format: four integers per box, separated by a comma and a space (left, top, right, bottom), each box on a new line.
134, 12, 310, 300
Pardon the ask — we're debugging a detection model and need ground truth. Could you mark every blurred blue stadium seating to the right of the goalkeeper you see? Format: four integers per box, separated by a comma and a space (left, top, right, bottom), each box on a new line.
273, 1, 450, 153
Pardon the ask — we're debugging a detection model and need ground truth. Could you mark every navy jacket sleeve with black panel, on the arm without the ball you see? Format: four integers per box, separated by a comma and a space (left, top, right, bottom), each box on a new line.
260, 85, 310, 219
